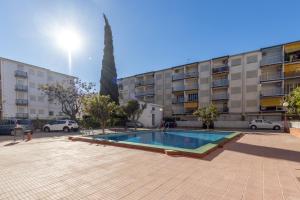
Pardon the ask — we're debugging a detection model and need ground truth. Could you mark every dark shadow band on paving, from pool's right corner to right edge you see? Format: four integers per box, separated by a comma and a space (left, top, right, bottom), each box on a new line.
203, 134, 300, 163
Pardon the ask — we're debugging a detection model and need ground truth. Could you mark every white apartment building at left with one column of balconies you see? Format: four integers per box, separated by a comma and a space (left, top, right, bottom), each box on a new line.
0, 58, 75, 119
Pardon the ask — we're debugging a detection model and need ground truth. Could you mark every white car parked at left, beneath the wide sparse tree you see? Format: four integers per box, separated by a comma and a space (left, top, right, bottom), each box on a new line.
43, 120, 79, 132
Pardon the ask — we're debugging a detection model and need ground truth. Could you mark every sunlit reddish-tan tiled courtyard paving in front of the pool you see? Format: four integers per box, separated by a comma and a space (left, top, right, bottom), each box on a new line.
0, 133, 300, 200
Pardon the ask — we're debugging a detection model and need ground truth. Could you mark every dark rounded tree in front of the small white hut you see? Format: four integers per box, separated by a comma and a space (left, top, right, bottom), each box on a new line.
124, 100, 147, 129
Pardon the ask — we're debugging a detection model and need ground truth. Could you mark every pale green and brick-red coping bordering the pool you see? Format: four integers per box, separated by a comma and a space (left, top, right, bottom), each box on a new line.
68, 130, 242, 158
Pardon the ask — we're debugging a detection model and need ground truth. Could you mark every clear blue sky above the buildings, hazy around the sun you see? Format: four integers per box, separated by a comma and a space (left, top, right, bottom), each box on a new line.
0, 0, 300, 88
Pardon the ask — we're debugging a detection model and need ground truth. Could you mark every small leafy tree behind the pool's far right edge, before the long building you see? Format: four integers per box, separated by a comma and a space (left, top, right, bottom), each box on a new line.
193, 104, 219, 128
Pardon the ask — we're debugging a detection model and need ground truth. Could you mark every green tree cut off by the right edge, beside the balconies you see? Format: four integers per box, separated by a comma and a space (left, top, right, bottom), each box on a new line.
285, 87, 300, 115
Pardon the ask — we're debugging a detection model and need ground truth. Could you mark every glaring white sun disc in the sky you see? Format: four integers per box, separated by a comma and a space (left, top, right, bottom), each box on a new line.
56, 28, 81, 52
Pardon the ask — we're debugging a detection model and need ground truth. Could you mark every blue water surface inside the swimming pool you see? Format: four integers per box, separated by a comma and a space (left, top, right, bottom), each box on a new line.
95, 131, 232, 149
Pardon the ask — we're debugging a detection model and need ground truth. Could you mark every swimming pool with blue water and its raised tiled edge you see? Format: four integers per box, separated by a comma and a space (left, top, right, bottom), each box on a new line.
80, 130, 240, 157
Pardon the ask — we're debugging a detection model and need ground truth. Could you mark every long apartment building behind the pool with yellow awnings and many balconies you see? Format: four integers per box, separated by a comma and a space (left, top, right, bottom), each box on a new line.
118, 41, 300, 121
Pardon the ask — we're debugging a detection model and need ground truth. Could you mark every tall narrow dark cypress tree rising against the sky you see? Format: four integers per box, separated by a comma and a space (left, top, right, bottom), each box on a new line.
100, 15, 119, 104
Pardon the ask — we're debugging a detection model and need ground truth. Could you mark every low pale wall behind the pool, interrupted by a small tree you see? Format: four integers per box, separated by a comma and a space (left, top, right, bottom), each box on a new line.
177, 121, 249, 128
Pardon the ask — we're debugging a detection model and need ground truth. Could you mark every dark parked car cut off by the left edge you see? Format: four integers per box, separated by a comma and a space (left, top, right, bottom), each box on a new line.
0, 119, 34, 135
